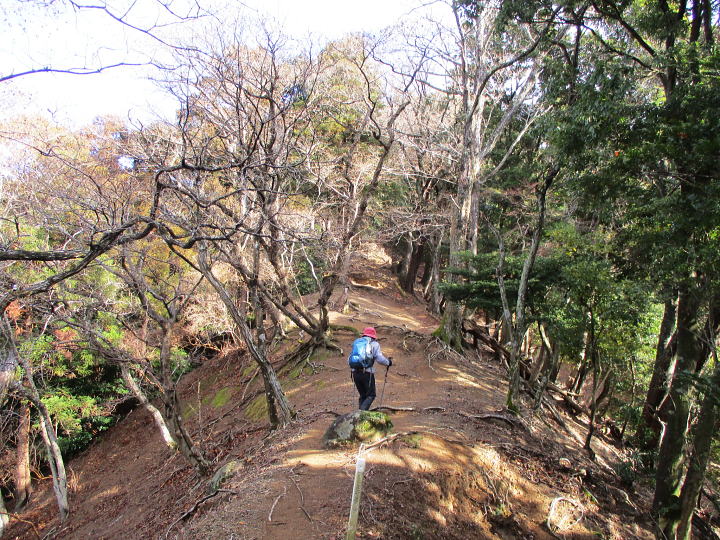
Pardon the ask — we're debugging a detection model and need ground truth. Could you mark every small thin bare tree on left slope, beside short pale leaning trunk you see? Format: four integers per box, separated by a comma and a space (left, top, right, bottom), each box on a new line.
65, 239, 209, 476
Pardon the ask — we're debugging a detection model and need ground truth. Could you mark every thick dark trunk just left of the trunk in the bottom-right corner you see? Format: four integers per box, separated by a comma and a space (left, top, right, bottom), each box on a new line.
653, 276, 703, 539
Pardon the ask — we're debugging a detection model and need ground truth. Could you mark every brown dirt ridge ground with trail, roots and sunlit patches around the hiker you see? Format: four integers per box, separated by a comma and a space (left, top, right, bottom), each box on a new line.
7, 247, 652, 540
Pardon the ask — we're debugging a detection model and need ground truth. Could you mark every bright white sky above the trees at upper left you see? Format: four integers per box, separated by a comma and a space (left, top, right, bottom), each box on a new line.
0, 0, 437, 127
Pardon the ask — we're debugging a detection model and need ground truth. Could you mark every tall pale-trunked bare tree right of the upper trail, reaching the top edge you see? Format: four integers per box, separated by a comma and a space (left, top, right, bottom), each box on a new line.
400, 2, 554, 348
